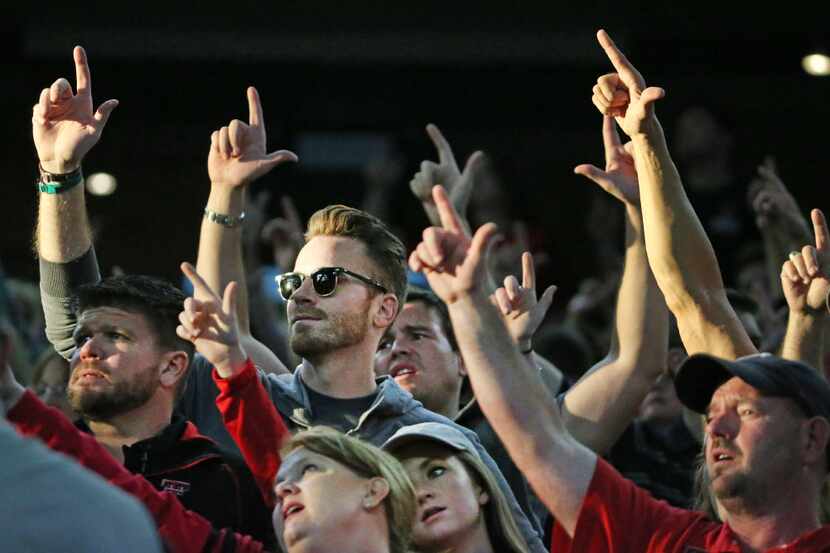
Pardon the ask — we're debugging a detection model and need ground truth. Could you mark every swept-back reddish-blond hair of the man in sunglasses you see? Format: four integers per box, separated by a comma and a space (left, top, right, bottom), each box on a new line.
305, 205, 406, 309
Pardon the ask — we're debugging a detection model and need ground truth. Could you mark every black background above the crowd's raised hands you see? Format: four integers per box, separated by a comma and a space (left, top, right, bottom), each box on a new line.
0, 1, 830, 298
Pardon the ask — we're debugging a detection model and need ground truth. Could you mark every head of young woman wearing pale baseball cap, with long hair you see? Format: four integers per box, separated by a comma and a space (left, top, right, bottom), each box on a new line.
383, 422, 527, 553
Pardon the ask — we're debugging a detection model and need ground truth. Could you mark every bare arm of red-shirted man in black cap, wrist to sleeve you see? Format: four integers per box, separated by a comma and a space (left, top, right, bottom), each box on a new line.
449, 288, 596, 531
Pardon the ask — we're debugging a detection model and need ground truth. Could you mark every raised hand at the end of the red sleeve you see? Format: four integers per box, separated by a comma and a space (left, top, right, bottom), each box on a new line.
176, 263, 247, 378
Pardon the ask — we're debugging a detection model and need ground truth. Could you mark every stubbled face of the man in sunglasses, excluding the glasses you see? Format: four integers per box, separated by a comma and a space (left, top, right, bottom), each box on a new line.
287, 236, 386, 359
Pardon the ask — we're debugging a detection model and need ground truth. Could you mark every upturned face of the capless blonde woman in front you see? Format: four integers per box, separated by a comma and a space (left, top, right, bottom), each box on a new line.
273, 448, 368, 553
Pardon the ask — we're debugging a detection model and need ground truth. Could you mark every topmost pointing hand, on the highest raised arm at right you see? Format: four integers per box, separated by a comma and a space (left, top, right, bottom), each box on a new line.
591, 30, 666, 137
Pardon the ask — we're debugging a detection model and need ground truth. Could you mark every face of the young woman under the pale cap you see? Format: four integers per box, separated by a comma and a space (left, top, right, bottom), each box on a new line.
395, 442, 489, 551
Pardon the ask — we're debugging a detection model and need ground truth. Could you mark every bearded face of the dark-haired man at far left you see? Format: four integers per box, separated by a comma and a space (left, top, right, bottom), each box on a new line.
68, 307, 163, 420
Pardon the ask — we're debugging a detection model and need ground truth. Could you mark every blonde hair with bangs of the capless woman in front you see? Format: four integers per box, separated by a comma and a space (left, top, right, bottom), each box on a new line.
282, 426, 417, 553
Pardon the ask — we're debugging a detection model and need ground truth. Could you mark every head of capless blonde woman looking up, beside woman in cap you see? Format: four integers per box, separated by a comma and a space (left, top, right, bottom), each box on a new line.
274, 427, 415, 553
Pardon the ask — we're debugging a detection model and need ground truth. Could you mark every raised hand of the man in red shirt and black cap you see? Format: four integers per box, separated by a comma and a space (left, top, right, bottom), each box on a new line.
409, 186, 496, 305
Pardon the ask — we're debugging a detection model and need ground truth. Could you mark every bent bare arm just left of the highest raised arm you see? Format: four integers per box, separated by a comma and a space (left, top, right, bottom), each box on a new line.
562, 207, 668, 454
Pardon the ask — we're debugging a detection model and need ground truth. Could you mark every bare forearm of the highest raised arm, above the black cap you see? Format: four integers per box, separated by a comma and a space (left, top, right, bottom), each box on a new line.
632, 118, 756, 359
